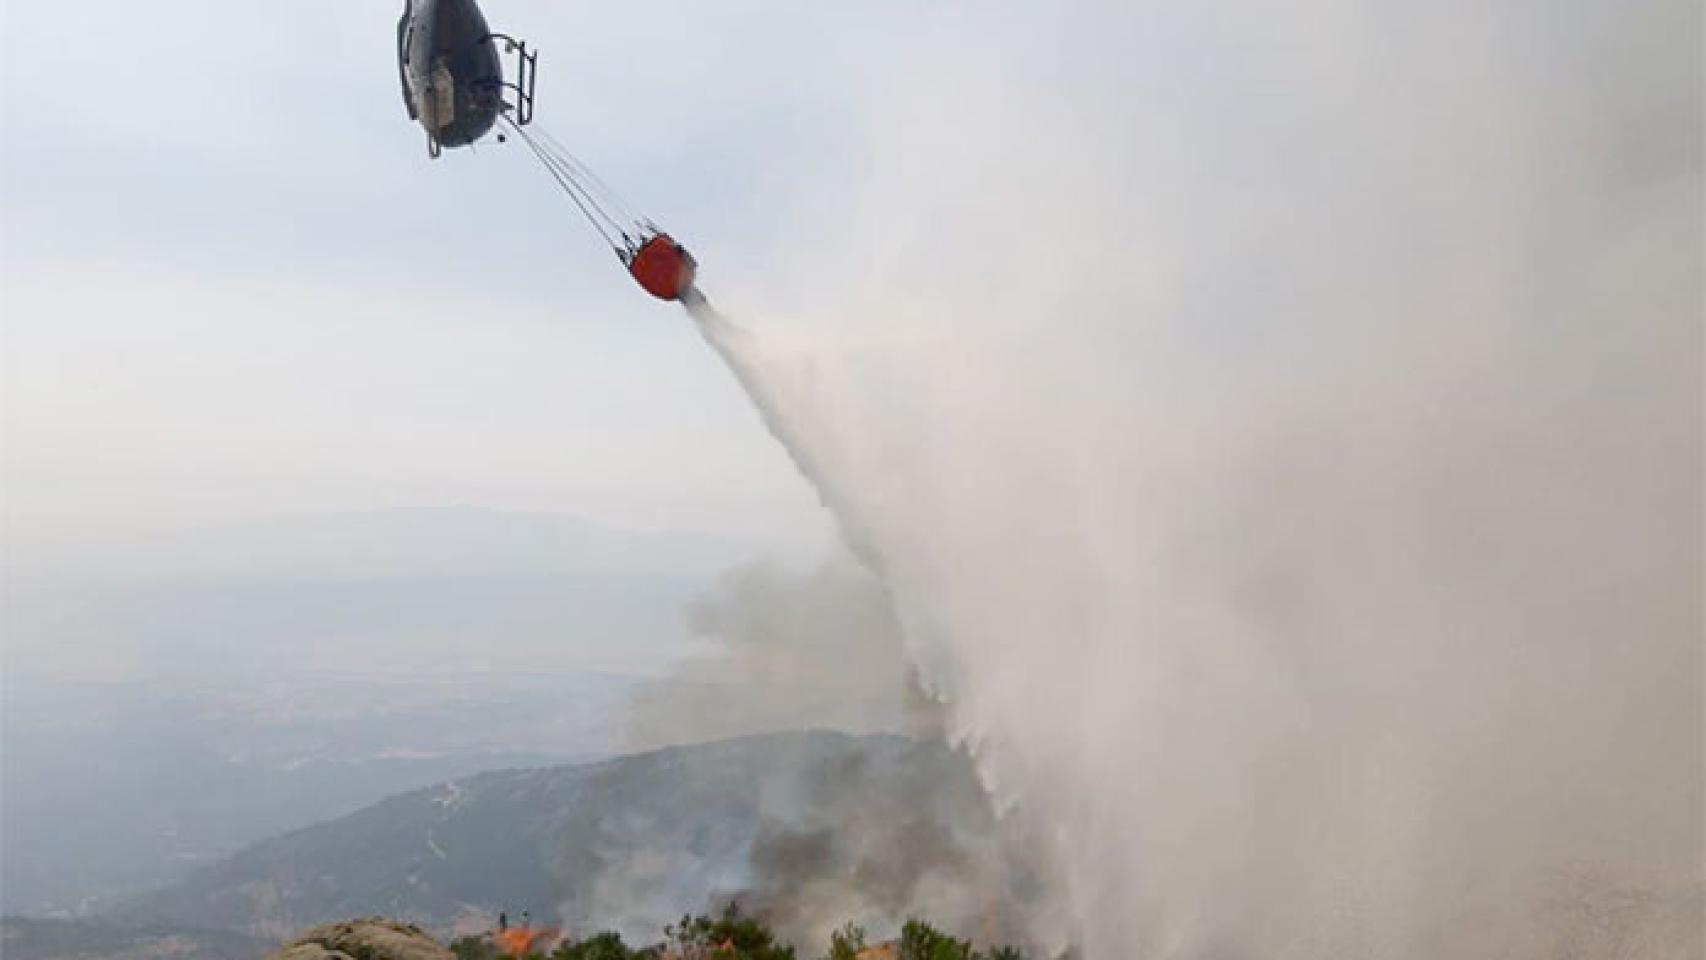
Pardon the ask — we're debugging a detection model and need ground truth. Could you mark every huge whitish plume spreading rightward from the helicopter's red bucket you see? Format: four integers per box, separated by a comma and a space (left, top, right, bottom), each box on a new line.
675, 2, 1706, 960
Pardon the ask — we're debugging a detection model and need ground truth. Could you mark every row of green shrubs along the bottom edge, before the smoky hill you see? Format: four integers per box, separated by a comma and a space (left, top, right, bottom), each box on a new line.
450, 905, 1025, 960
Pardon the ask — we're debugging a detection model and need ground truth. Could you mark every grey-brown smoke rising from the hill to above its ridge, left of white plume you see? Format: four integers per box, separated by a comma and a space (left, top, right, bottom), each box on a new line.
617, 556, 1042, 948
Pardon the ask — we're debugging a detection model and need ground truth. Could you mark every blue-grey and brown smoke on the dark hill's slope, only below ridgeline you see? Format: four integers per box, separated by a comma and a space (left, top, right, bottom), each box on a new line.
554, 732, 1047, 951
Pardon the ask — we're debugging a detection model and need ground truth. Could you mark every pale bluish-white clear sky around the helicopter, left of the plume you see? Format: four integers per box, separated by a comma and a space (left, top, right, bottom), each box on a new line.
0, 0, 896, 559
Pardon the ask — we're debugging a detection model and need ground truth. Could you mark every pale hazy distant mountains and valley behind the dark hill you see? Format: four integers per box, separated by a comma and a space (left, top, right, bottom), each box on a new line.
0, 508, 747, 919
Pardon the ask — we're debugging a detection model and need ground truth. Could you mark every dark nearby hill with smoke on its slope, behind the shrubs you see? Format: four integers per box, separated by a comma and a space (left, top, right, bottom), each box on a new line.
106, 733, 1010, 941
